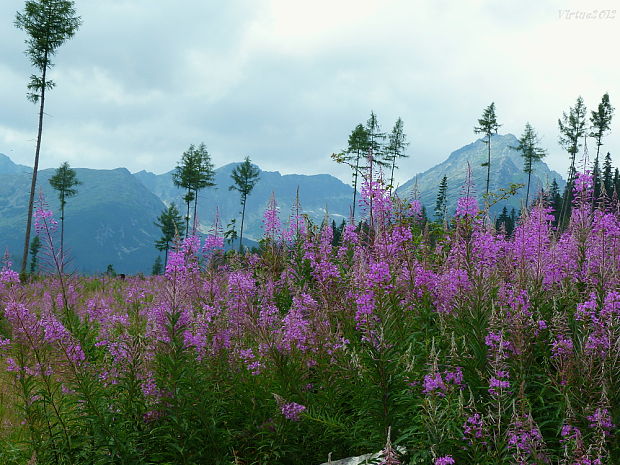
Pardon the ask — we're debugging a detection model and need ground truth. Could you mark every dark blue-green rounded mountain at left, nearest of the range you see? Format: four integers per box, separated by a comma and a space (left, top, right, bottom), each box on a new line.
0, 168, 165, 273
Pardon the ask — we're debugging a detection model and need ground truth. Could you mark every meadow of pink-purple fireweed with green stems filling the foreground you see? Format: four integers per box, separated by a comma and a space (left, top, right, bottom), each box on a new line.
0, 174, 620, 465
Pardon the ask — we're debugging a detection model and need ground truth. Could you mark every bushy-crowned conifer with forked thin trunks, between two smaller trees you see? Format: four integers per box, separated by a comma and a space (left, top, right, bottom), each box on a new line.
172, 143, 215, 237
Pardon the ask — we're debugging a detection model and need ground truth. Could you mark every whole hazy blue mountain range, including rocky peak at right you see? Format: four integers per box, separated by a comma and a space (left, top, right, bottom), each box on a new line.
0, 134, 564, 274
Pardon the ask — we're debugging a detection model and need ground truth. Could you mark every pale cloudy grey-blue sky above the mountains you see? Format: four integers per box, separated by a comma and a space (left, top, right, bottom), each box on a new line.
0, 0, 620, 188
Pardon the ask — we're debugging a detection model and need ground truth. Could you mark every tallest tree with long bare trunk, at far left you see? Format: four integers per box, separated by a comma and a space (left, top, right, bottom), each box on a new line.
15, 0, 81, 274
